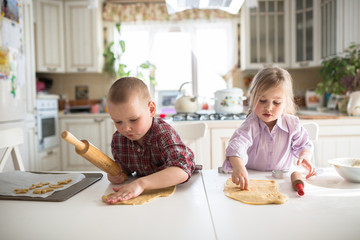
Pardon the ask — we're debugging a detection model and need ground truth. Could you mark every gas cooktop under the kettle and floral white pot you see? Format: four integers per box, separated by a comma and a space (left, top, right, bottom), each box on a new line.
172, 113, 246, 121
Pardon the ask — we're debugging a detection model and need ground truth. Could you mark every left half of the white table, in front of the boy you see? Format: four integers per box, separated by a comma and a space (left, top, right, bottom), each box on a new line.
0, 173, 215, 240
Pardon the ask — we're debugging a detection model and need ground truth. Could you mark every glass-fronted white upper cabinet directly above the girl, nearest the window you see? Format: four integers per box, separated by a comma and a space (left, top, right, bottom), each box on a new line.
241, 0, 290, 69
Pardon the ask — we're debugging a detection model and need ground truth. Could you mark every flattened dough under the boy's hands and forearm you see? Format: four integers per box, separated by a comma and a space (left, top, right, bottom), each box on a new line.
102, 186, 176, 205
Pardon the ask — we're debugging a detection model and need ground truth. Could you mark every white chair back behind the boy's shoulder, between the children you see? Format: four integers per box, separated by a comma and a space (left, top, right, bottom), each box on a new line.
171, 122, 210, 168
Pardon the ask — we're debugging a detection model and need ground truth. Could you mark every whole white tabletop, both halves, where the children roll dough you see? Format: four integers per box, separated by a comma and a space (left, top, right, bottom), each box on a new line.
0, 168, 360, 240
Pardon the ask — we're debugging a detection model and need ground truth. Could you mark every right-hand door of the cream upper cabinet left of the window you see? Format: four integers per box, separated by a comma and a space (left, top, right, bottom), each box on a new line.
65, 1, 103, 72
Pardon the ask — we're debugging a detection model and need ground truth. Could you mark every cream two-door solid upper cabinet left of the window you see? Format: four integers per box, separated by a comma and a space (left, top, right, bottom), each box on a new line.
36, 0, 103, 73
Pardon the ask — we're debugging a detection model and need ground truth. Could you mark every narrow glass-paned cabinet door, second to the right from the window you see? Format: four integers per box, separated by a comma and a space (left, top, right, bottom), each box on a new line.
291, 0, 321, 67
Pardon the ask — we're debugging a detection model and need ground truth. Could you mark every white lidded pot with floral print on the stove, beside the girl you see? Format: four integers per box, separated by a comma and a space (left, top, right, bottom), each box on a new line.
215, 88, 246, 114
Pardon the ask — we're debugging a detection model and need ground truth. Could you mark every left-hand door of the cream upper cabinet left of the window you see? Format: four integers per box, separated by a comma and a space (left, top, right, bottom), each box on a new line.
36, 0, 65, 72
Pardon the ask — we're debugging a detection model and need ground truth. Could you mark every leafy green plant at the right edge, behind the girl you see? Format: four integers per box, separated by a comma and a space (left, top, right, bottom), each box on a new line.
316, 44, 360, 113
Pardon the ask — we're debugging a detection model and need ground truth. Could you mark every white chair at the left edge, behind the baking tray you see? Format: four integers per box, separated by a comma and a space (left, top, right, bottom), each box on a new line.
0, 128, 25, 172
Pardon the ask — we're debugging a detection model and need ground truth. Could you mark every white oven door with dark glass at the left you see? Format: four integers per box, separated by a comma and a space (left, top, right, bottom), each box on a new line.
37, 110, 59, 151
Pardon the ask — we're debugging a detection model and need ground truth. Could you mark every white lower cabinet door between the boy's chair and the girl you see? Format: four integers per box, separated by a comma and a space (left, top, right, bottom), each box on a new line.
211, 128, 235, 169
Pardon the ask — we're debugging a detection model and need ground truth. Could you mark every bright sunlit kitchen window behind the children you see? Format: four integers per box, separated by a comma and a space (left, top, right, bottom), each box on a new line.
113, 20, 237, 109
